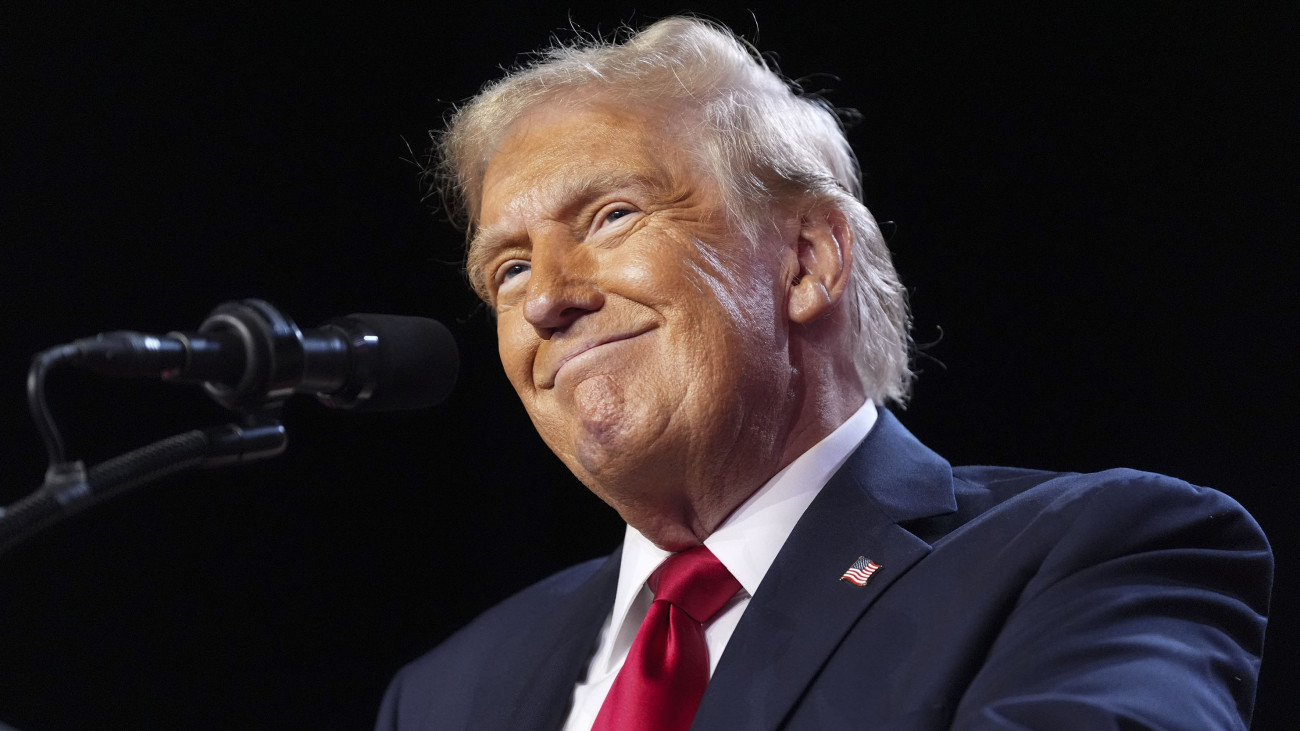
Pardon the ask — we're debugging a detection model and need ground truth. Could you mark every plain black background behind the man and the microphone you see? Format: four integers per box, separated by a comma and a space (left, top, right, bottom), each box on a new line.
0, 1, 1300, 731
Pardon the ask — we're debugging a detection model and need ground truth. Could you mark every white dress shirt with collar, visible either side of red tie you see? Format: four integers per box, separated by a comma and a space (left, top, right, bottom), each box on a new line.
564, 401, 876, 731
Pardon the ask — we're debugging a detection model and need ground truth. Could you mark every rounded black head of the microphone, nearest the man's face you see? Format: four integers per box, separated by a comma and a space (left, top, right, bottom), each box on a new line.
317, 313, 460, 411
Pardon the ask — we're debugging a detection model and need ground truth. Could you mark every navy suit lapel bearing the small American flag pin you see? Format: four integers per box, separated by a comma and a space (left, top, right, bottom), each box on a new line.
693, 411, 957, 730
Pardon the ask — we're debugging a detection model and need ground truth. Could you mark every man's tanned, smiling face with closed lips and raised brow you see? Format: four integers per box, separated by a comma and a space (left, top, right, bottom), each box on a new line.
469, 104, 797, 518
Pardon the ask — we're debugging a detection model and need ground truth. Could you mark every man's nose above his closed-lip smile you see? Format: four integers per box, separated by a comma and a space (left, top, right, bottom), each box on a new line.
524, 230, 605, 339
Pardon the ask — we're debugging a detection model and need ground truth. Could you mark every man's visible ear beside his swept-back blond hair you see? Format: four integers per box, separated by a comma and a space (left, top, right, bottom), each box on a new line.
787, 203, 854, 325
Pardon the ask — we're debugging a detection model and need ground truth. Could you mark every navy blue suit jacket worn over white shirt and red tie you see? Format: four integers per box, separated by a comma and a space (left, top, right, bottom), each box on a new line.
378, 412, 1273, 731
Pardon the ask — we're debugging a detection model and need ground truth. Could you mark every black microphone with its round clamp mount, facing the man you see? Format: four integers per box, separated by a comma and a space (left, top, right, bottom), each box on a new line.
70, 299, 460, 412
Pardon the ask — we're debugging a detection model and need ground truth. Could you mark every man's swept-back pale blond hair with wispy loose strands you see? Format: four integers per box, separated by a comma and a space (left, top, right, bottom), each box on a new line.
433, 17, 911, 403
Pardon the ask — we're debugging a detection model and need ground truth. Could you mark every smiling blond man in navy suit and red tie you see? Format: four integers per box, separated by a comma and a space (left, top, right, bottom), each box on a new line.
378, 18, 1271, 730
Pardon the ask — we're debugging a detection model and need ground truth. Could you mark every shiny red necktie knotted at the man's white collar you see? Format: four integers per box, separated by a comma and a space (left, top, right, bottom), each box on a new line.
592, 546, 740, 731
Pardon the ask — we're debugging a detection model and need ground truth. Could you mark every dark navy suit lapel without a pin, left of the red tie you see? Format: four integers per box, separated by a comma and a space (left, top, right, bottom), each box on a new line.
491, 546, 623, 731
